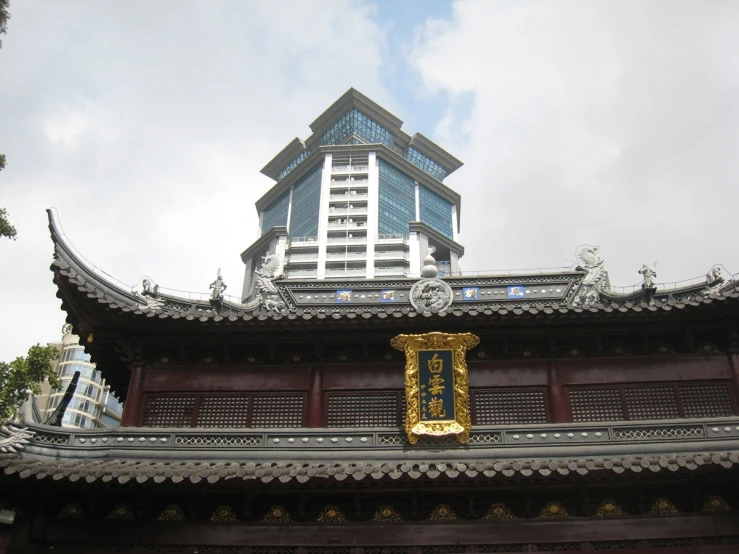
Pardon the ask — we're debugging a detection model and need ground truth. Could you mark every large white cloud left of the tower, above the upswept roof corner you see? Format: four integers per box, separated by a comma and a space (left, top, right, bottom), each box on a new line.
0, 0, 394, 359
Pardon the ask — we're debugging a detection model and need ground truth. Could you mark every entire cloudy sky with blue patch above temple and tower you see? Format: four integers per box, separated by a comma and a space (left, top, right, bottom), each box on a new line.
0, 0, 739, 360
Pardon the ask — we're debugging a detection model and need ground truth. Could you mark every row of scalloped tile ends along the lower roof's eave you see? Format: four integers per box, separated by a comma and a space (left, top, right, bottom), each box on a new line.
0, 452, 739, 484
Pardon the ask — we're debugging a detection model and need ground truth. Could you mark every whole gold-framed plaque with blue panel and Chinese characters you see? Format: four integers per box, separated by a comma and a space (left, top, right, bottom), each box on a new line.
390, 333, 480, 444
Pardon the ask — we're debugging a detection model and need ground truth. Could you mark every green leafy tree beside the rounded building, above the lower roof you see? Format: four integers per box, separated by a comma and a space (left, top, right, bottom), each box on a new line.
0, 342, 61, 423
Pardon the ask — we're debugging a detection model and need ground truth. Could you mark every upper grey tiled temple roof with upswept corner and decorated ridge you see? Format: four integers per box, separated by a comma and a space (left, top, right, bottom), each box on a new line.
49, 210, 739, 324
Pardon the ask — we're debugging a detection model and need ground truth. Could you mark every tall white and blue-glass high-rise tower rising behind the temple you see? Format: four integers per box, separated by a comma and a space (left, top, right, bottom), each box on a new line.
242, 89, 464, 298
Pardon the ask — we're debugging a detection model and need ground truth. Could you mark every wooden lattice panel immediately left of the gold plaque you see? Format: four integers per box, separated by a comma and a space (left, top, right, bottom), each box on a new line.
326, 392, 400, 427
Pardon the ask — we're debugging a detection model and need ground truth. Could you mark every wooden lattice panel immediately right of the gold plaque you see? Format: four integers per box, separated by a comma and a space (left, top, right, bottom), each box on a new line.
473, 389, 547, 425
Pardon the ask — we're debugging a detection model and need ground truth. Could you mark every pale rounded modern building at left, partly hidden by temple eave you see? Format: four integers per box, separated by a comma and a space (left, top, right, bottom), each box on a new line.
36, 325, 123, 428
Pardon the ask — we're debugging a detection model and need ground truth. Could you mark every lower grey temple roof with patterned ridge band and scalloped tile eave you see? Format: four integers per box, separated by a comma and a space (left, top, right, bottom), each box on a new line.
5, 418, 739, 483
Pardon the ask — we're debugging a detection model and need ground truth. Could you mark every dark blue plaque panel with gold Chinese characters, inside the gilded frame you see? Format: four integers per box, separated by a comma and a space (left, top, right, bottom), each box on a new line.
418, 350, 455, 422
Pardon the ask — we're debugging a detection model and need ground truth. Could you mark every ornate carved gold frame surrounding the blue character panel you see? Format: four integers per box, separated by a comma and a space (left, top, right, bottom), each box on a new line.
390, 332, 480, 444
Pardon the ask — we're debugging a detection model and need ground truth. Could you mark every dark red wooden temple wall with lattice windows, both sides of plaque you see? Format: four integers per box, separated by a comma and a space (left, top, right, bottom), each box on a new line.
122, 354, 739, 427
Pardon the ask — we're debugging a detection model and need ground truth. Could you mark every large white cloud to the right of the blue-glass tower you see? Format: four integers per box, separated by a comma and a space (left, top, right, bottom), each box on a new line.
409, 0, 739, 285
